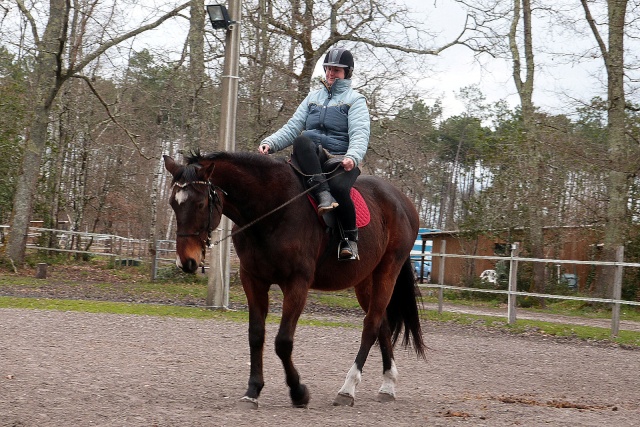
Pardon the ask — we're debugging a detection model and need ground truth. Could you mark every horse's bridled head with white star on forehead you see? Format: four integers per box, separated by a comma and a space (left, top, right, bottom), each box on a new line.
163, 154, 222, 273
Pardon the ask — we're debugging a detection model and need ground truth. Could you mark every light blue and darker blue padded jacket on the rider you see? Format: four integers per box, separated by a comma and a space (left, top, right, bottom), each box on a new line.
260, 79, 370, 166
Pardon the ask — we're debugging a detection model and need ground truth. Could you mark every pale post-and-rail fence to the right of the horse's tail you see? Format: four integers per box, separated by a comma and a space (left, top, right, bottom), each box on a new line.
419, 241, 640, 337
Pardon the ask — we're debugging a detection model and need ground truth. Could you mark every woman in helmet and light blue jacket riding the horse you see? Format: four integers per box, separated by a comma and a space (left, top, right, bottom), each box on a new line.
258, 48, 369, 260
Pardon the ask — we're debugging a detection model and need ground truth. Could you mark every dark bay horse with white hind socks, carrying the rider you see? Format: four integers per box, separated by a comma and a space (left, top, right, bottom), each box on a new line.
164, 152, 425, 407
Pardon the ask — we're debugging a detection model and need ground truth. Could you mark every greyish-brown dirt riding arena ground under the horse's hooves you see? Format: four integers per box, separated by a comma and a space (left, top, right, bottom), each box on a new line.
0, 309, 640, 427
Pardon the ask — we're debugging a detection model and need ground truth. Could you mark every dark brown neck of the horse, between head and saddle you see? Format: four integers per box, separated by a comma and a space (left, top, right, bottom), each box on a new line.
212, 157, 303, 226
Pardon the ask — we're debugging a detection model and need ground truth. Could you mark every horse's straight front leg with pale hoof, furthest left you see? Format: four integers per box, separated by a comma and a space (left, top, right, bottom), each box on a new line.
240, 273, 269, 409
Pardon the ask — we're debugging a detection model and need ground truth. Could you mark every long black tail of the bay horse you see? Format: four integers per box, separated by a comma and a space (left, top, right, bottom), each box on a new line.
387, 259, 427, 359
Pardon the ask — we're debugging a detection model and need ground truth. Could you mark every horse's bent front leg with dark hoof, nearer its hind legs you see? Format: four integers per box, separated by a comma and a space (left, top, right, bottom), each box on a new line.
275, 284, 310, 408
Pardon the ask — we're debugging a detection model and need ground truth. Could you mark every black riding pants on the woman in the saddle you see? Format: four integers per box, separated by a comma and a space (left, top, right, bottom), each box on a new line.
293, 136, 360, 230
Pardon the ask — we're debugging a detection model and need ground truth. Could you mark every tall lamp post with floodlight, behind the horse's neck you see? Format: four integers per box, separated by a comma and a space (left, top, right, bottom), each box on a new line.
207, 0, 241, 308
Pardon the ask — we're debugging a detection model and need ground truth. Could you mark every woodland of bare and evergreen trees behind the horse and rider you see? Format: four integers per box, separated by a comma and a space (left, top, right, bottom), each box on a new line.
0, 0, 640, 299
